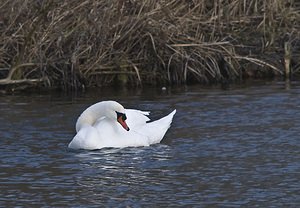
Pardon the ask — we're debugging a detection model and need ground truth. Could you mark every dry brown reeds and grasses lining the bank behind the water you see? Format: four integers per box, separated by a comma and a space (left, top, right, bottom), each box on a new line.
0, 0, 300, 90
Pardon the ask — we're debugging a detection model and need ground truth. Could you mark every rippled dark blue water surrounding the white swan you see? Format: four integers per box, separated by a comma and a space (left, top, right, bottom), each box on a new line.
0, 82, 300, 207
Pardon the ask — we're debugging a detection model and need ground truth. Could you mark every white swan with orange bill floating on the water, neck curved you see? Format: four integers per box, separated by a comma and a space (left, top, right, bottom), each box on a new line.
68, 101, 176, 150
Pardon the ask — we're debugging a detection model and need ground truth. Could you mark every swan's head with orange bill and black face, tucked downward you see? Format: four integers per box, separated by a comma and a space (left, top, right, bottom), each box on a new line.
107, 101, 129, 131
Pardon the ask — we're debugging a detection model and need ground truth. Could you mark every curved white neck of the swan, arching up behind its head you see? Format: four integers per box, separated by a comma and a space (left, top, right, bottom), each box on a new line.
76, 102, 107, 132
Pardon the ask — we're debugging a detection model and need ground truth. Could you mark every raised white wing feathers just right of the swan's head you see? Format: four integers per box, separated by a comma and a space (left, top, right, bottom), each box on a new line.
125, 109, 150, 128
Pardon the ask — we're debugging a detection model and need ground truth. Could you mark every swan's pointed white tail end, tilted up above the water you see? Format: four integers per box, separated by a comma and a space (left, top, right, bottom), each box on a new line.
145, 110, 176, 144
